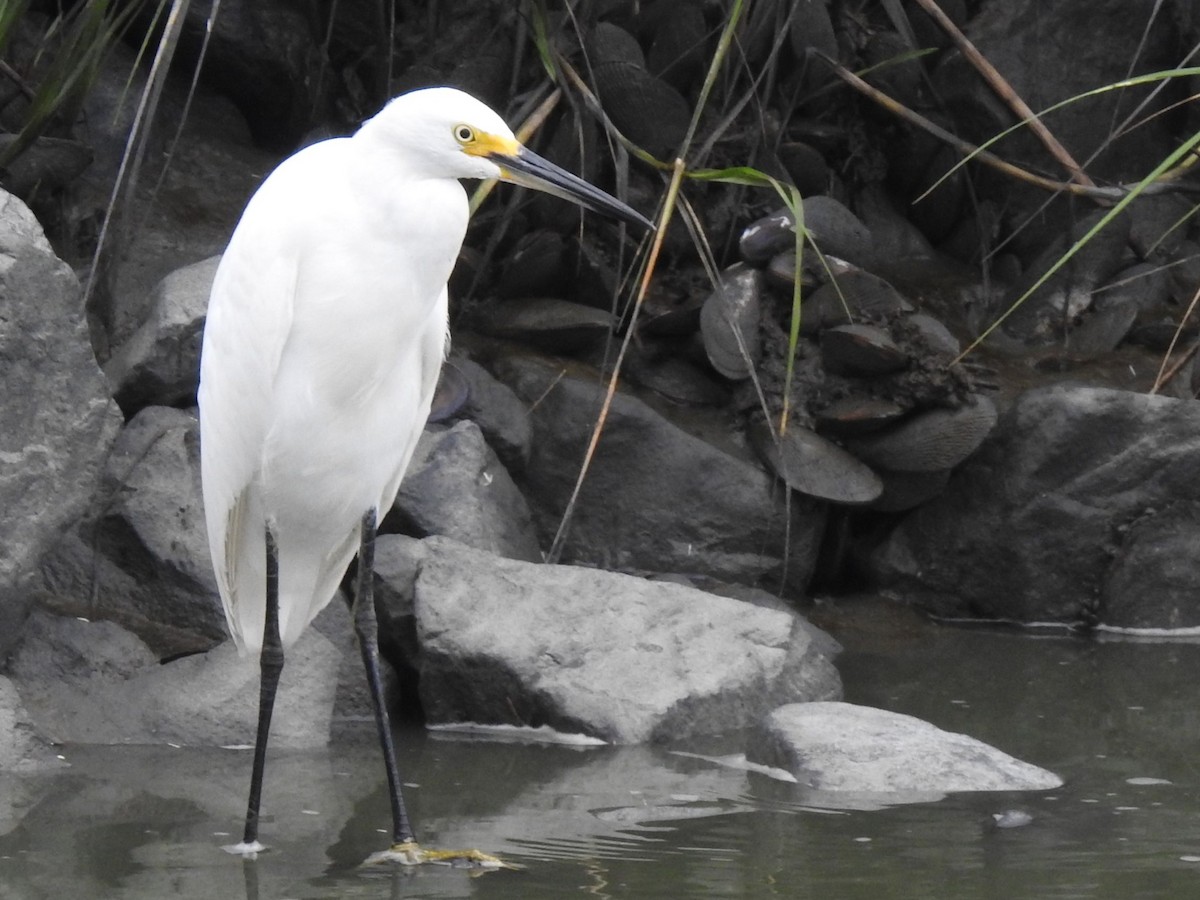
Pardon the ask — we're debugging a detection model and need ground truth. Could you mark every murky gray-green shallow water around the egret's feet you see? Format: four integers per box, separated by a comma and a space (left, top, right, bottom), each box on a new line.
0, 604, 1200, 900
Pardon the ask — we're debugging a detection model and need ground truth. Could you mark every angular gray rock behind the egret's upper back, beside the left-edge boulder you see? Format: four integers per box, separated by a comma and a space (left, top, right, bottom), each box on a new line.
104, 257, 221, 415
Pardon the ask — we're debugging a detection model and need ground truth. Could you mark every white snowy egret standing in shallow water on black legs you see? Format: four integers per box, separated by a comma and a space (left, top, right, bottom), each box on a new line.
199, 88, 652, 862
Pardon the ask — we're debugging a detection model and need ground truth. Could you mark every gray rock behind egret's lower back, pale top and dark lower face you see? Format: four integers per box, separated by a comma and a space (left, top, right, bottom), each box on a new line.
42, 407, 227, 656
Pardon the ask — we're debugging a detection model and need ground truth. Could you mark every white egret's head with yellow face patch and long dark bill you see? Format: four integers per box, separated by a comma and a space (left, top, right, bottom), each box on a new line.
362, 88, 653, 228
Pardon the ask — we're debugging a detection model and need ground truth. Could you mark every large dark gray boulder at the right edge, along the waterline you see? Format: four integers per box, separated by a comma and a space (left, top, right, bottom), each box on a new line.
872, 385, 1200, 628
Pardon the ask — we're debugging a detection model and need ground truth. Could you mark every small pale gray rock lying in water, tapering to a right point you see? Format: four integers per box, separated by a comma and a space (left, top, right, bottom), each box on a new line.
748, 702, 1062, 803
